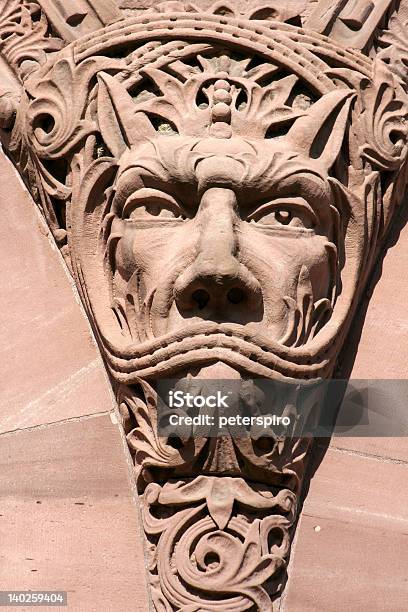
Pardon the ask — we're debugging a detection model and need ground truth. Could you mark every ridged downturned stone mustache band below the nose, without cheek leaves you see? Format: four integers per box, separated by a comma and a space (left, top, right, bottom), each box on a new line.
104, 321, 331, 384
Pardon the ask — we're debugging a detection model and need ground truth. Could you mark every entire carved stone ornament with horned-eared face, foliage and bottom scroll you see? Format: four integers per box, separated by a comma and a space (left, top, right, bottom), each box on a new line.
0, 0, 408, 612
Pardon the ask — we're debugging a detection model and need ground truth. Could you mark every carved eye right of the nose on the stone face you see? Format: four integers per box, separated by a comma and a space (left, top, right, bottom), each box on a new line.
247, 198, 317, 229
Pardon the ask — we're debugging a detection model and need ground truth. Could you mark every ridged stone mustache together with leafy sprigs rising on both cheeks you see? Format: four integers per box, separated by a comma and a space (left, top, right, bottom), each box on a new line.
108, 266, 332, 384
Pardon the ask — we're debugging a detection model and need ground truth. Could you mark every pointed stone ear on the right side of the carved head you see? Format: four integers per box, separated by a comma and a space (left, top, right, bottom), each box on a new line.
287, 89, 356, 170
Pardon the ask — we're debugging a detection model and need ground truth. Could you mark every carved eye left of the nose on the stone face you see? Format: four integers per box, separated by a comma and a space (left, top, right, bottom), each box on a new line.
122, 188, 186, 221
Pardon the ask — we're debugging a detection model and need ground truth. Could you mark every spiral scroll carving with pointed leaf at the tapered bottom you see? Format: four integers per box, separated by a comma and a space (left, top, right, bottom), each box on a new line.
142, 476, 295, 610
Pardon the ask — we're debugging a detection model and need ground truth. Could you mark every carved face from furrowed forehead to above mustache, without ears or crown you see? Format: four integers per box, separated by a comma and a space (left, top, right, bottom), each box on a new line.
112, 136, 334, 345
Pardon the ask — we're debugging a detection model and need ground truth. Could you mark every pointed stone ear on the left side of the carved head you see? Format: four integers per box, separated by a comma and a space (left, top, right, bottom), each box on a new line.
98, 72, 156, 159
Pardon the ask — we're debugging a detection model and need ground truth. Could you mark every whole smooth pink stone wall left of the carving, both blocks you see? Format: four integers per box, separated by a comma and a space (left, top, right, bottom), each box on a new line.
0, 147, 148, 612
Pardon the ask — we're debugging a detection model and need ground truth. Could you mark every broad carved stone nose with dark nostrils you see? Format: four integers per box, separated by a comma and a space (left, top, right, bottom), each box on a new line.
174, 188, 261, 320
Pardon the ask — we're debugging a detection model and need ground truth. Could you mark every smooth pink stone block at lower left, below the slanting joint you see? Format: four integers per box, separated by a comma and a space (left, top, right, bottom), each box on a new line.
0, 415, 149, 612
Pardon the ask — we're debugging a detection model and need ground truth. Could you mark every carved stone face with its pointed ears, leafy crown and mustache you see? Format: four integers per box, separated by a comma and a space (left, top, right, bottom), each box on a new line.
73, 64, 360, 384
